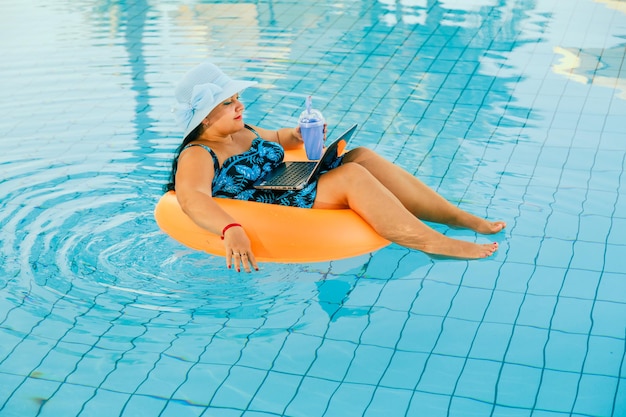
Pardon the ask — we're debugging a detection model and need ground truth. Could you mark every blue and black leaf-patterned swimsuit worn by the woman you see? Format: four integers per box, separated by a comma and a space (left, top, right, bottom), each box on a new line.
185, 125, 343, 208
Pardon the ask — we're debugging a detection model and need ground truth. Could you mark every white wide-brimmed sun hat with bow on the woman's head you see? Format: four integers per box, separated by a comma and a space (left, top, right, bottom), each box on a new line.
174, 62, 257, 137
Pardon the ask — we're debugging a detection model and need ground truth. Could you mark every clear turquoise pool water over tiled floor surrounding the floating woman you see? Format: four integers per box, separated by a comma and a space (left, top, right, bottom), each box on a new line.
0, 0, 626, 417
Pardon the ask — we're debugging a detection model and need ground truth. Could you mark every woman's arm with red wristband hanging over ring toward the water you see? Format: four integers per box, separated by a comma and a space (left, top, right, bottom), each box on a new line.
176, 146, 259, 272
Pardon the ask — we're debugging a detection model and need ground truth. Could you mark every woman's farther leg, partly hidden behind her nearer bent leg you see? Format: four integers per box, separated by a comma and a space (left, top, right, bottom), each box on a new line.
344, 148, 506, 234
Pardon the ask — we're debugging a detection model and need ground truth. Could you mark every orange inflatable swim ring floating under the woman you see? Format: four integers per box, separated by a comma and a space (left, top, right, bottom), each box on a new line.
154, 150, 390, 263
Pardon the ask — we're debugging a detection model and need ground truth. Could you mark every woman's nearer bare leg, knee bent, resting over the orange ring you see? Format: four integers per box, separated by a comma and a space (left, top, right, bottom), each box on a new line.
313, 162, 498, 259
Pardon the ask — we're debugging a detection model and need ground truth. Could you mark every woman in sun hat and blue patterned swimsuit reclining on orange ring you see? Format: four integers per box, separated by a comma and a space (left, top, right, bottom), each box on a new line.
168, 63, 506, 272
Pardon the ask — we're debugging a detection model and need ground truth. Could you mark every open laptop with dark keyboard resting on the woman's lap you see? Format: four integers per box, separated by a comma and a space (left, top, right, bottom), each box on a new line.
254, 124, 357, 190
